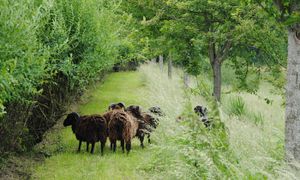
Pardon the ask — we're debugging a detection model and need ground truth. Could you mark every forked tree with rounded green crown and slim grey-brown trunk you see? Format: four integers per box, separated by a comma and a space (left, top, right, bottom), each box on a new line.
173, 0, 284, 101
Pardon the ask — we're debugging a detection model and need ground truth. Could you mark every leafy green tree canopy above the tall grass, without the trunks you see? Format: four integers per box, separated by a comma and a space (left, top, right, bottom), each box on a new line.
123, 0, 287, 100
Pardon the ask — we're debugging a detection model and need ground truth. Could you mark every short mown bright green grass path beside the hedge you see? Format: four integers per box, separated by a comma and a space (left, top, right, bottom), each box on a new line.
32, 72, 155, 180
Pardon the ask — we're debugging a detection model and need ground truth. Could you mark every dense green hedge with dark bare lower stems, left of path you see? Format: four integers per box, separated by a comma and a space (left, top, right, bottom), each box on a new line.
0, 0, 125, 152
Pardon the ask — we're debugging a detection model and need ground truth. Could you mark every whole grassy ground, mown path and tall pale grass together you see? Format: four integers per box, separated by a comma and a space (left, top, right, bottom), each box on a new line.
32, 64, 299, 179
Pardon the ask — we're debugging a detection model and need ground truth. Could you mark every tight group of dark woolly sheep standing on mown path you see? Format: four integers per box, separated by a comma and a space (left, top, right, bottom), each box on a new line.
63, 103, 164, 155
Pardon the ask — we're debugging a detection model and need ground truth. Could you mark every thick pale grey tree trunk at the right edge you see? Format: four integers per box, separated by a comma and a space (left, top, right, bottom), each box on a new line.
285, 30, 300, 162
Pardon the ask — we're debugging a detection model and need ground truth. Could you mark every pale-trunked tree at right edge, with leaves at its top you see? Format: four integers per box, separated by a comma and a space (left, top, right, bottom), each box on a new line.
264, 0, 300, 161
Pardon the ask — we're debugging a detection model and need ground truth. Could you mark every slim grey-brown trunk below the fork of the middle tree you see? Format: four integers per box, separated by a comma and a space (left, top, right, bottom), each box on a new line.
212, 59, 221, 102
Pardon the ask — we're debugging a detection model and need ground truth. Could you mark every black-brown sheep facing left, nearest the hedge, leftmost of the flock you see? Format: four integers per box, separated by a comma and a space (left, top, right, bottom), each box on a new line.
64, 112, 107, 155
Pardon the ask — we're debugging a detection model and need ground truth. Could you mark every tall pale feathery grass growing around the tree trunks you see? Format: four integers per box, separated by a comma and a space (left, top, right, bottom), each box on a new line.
140, 63, 299, 179
